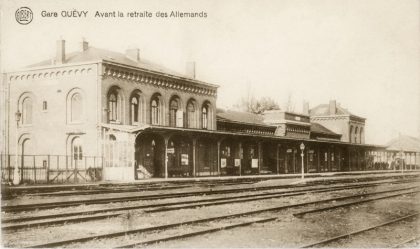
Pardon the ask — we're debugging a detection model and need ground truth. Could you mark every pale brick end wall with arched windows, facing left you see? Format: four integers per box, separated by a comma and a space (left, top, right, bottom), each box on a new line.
6, 64, 100, 156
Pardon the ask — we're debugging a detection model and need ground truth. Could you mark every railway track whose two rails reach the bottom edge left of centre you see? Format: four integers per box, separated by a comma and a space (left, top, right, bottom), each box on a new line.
19, 186, 420, 248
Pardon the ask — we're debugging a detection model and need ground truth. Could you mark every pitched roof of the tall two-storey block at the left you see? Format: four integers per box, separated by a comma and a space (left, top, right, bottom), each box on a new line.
28, 47, 194, 80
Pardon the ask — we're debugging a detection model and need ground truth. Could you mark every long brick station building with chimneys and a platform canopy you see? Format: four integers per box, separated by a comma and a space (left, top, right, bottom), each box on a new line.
1, 40, 414, 182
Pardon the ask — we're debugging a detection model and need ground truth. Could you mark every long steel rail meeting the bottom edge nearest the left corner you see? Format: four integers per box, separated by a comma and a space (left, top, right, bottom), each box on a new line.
28, 189, 420, 248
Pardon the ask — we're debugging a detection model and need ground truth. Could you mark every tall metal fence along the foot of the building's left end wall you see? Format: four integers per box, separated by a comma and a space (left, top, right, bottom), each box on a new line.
0, 154, 103, 184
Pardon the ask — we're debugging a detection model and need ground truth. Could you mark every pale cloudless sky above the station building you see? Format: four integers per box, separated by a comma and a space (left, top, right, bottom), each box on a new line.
0, 0, 420, 144
